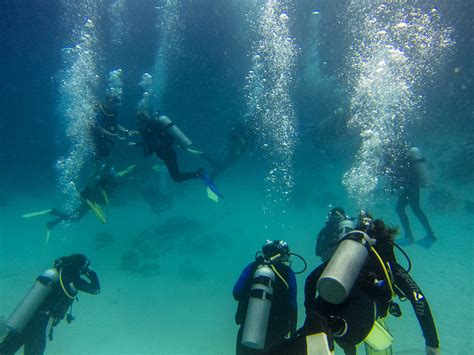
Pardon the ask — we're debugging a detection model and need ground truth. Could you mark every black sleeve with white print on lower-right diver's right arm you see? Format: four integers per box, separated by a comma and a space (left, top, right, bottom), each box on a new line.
393, 264, 439, 354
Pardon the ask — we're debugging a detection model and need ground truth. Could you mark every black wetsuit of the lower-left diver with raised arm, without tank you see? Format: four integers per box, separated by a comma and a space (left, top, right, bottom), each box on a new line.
0, 267, 100, 355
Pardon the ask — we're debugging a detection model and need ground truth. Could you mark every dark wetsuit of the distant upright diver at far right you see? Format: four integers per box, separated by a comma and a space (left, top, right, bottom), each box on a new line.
392, 157, 434, 240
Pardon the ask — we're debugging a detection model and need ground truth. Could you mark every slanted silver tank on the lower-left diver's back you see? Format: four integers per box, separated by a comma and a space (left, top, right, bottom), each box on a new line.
5, 269, 59, 333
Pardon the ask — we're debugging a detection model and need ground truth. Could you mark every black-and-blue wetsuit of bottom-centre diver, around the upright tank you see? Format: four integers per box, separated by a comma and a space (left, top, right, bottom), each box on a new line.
232, 262, 298, 355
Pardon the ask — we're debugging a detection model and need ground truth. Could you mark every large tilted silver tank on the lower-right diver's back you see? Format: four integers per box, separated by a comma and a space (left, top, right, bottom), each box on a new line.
317, 230, 374, 304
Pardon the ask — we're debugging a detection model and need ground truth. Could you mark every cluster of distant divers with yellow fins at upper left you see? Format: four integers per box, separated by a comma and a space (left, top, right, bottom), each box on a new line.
23, 89, 255, 243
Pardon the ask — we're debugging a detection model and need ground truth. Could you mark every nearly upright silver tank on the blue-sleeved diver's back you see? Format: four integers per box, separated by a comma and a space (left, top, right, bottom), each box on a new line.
241, 265, 275, 349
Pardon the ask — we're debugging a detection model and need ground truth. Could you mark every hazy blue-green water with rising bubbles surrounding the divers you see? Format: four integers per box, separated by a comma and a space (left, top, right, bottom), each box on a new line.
0, 0, 474, 355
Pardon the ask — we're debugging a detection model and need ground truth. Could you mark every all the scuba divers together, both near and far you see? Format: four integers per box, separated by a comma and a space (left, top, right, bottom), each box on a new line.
9, 74, 440, 355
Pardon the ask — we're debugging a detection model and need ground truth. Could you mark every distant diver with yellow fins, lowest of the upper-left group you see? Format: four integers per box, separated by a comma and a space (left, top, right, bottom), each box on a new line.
22, 161, 135, 245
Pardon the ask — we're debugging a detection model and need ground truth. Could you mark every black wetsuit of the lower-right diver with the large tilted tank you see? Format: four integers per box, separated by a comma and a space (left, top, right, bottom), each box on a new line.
302, 235, 439, 354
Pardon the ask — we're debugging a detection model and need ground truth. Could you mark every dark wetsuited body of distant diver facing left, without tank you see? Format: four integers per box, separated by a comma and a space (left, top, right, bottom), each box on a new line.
137, 112, 204, 182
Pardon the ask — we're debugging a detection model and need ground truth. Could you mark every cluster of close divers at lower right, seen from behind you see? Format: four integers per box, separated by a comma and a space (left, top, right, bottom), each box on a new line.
233, 207, 440, 355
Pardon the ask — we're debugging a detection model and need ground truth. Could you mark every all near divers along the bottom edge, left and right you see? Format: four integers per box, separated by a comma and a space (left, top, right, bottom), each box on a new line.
0, 207, 440, 355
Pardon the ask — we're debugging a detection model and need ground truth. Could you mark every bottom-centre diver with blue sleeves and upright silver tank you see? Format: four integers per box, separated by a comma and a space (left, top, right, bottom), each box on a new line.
232, 240, 306, 355
